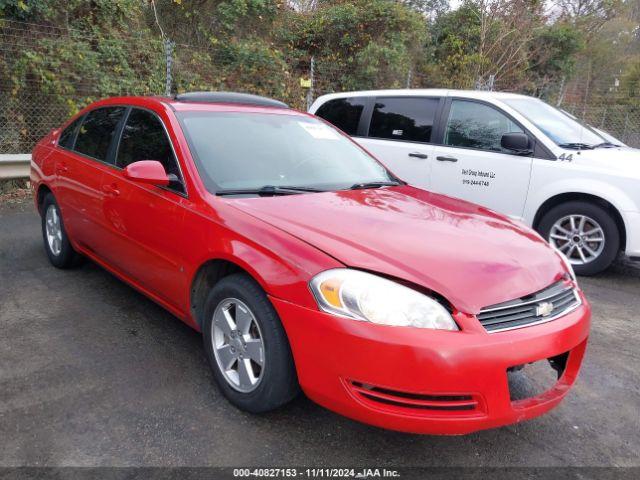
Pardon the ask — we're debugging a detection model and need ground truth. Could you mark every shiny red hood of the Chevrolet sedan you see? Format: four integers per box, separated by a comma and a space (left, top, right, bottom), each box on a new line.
228, 186, 564, 314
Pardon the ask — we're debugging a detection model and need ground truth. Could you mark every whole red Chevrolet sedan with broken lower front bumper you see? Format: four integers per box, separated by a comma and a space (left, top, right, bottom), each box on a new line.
31, 93, 590, 434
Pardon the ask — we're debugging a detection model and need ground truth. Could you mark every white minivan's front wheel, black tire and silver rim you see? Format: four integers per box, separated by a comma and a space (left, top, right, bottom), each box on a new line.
538, 201, 620, 276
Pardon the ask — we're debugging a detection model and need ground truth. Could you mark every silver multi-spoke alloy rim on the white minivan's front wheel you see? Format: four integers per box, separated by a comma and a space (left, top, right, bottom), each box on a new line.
549, 215, 605, 265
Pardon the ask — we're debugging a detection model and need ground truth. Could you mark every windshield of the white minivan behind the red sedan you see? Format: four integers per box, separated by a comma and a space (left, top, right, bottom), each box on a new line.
503, 98, 605, 147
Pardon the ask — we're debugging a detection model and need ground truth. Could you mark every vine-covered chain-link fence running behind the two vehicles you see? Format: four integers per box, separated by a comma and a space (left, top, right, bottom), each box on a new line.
0, 20, 640, 153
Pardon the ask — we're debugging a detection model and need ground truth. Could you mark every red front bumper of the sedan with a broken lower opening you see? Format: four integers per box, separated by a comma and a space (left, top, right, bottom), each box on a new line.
271, 294, 591, 434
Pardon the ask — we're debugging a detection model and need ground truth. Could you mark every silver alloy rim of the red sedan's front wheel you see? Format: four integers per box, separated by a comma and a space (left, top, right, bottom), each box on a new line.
211, 298, 265, 393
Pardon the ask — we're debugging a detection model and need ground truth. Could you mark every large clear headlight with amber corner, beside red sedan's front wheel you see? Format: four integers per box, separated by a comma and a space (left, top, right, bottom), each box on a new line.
310, 268, 458, 330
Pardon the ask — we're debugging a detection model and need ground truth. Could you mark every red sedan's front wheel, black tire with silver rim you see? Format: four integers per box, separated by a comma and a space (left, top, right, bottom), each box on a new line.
202, 273, 300, 413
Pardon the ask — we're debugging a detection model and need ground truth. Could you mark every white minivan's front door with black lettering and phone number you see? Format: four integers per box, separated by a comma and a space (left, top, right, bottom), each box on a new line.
430, 98, 532, 219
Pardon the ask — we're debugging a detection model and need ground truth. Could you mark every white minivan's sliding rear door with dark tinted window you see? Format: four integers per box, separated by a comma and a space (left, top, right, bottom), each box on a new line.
354, 96, 440, 188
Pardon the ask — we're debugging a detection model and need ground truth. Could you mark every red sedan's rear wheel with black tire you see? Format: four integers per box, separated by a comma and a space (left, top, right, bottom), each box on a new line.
41, 193, 79, 268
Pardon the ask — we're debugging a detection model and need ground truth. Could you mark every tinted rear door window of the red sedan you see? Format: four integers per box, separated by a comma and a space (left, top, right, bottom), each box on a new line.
74, 107, 125, 162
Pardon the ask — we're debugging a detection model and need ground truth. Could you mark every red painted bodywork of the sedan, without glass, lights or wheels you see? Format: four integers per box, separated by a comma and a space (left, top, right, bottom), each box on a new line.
31, 97, 590, 434
